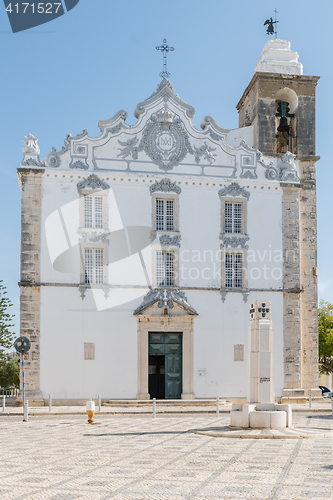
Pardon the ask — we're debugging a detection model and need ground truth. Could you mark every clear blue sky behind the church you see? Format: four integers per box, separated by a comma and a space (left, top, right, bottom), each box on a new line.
0, 0, 333, 333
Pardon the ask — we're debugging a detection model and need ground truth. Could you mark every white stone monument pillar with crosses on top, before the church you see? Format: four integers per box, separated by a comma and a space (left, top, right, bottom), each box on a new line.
247, 300, 275, 403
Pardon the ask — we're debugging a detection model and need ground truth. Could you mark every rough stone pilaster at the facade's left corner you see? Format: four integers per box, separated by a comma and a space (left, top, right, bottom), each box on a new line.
18, 168, 44, 401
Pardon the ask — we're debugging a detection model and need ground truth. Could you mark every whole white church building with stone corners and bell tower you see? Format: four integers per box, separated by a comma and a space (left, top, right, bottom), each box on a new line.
18, 39, 320, 402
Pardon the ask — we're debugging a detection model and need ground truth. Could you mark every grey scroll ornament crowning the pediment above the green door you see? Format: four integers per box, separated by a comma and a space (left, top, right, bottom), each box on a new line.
133, 288, 198, 315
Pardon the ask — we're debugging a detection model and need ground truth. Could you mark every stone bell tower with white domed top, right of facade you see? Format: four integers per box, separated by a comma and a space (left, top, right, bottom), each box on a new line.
237, 39, 320, 399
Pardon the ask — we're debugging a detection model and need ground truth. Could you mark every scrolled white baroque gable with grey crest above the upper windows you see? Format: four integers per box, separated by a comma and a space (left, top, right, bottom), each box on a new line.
43, 78, 298, 182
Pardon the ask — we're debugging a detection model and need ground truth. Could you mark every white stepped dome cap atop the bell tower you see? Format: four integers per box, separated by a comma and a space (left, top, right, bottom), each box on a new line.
254, 38, 303, 75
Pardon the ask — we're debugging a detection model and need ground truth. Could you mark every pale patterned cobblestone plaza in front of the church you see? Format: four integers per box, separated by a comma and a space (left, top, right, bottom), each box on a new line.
0, 413, 333, 500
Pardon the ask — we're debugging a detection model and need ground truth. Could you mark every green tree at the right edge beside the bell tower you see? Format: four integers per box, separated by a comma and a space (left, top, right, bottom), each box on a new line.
318, 300, 333, 373
